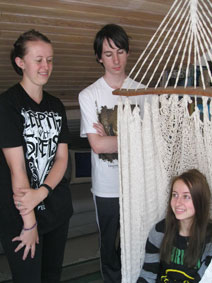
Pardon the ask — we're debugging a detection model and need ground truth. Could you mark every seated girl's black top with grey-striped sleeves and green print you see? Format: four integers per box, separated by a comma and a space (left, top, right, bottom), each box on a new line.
138, 219, 212, 283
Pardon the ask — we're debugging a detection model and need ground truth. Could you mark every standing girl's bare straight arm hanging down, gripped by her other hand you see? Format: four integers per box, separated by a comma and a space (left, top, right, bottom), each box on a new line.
2, 146, 38, 260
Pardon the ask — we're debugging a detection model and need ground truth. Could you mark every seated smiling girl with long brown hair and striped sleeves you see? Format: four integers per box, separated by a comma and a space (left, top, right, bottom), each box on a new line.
137, 169, 212, 283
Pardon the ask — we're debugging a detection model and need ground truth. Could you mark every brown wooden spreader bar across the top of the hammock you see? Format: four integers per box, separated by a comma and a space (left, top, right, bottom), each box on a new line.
113, 87, 212, 97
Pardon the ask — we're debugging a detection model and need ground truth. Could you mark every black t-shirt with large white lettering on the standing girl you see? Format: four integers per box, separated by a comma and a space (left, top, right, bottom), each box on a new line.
0, 84, 72, 233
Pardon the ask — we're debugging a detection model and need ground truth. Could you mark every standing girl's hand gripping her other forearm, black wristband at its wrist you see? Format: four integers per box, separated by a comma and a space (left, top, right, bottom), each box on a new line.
13, 188, 44, 215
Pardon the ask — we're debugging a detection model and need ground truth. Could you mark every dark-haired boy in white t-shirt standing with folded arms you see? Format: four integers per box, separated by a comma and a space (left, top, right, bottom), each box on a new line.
79, 24, 147, 283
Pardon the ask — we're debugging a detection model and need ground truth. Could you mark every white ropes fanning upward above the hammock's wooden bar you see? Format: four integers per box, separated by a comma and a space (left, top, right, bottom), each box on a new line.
114, 0, 212, 96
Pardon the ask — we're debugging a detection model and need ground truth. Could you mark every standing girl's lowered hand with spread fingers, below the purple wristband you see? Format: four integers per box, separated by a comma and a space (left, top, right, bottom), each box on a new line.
12, 227, 39, 260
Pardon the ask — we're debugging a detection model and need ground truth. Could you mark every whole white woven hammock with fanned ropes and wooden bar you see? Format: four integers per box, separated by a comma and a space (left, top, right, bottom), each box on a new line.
114, 0, 212, 283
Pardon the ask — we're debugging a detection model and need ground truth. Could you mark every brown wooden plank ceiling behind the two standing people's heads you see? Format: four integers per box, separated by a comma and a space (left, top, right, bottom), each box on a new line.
0, 0, 173, 108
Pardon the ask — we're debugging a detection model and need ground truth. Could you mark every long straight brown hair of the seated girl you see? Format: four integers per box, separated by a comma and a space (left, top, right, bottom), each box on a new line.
160, 169, 211, 267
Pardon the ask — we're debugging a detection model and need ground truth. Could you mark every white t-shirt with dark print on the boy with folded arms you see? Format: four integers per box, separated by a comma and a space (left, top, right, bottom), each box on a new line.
79, 77, 147, 197
